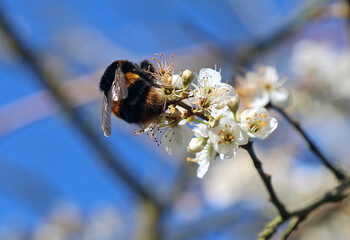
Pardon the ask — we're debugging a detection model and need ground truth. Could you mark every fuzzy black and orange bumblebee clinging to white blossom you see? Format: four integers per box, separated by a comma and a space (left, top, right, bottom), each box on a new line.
99, 60, 166, 137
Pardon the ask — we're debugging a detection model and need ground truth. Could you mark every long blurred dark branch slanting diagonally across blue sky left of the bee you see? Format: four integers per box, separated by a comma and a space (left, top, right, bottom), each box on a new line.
0, 0, 162, 218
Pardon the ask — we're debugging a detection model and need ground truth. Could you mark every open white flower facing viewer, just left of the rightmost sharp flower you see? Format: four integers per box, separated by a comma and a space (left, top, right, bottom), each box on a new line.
209, 117, 248, 159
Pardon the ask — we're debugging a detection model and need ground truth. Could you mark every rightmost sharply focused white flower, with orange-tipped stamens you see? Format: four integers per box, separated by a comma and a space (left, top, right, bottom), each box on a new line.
241, 107, 278, 139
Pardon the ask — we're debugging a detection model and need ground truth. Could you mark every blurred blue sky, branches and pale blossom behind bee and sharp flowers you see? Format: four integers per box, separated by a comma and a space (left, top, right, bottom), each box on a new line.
0, 0, 350, 240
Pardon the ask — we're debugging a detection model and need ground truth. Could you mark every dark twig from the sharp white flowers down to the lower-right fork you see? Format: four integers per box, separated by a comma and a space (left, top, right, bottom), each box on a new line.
242, 141, 290, 219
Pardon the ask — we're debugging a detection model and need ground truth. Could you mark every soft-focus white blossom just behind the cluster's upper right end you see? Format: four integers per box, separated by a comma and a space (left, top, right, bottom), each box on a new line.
236, 66, 290, 108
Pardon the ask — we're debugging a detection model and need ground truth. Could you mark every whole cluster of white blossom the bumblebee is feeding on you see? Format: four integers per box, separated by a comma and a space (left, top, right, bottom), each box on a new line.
136, 55, 290, 178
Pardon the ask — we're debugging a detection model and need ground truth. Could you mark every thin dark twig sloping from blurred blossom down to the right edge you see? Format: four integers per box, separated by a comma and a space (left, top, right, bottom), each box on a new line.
268, 104, 346, 181
